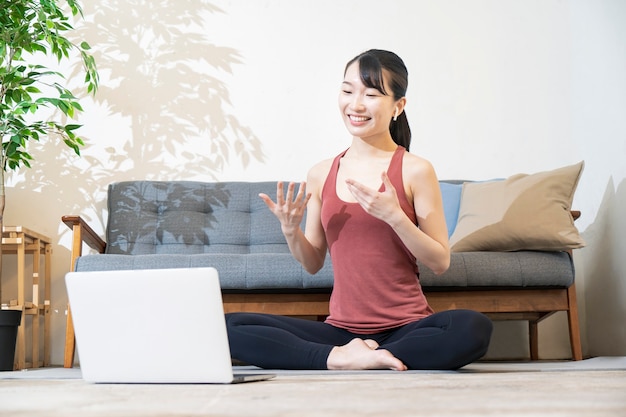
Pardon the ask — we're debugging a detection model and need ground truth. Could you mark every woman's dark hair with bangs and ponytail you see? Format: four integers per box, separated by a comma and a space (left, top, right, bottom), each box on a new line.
344, 49, 411, 151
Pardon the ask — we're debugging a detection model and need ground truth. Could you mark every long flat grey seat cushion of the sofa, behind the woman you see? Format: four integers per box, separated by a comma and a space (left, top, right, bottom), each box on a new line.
76, 247, 574, 292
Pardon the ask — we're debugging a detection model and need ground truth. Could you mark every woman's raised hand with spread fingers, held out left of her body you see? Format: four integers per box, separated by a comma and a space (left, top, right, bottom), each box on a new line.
259, 181, 311, 235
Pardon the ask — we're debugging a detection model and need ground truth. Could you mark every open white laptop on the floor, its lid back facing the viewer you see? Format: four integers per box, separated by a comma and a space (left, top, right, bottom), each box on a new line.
65, 268, 275, 384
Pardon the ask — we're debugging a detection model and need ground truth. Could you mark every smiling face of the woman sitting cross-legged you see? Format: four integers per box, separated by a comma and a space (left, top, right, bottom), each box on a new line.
339, 62, 401, 139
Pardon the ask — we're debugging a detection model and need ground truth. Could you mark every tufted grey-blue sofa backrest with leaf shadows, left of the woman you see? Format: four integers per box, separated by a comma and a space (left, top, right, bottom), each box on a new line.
106, 181, 289, 255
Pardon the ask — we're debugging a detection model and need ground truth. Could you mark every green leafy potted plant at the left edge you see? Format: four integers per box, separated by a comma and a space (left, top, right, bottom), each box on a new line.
0, 0, 98, 368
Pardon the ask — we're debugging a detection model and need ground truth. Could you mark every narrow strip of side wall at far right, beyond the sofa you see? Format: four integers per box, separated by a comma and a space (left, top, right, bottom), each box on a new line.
569, 0, 626, 355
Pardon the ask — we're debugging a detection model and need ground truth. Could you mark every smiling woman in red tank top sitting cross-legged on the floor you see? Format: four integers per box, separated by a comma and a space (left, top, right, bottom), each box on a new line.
227, 50, 492, 371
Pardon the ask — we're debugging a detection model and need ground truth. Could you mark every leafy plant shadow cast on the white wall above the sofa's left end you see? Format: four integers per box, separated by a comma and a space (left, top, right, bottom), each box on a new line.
9, 0, 264, 231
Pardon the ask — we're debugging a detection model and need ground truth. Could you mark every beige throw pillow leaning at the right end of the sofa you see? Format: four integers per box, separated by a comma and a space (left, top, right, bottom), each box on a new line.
450, 161, 585, 252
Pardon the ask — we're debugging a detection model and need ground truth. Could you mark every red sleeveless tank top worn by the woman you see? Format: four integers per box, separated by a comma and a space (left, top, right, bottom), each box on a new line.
321, 146, 433, 334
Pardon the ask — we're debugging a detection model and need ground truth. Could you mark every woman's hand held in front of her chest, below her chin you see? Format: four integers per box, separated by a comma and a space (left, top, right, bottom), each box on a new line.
346, 172, 403, 223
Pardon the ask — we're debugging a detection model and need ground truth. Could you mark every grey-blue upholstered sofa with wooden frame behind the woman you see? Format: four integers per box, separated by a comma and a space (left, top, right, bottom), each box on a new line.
62, 161, 584, 367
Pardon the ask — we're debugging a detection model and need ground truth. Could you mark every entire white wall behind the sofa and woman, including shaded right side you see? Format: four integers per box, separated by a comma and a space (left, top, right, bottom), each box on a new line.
3, 0, 626, 363
